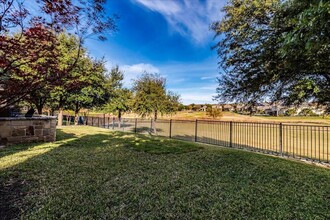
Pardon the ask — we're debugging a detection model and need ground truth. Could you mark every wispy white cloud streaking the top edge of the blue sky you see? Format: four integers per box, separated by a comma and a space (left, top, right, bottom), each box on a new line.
135, 0, 226, 43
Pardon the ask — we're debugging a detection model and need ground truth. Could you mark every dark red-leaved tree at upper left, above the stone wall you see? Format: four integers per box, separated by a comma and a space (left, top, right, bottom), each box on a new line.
0, 0, 116, 110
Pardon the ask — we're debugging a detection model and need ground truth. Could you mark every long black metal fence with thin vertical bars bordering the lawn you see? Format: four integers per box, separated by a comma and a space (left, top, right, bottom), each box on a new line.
63, 116, 330, 163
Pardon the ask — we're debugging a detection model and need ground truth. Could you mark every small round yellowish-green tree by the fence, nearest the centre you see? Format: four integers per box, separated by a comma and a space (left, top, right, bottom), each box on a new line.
133, 73, 179, 120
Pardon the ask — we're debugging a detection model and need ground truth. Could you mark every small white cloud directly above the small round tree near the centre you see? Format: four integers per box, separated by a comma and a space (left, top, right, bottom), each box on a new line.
119, 63, 160, 86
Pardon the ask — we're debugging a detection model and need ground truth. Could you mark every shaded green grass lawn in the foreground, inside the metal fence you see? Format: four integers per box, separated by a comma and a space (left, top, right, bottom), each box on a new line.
0, 126, 330, 219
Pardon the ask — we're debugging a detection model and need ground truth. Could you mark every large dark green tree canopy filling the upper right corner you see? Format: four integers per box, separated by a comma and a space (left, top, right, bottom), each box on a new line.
212, 0, 330, 109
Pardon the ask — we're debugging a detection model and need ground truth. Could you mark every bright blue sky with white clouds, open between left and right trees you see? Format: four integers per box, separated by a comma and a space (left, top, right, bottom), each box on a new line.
86, 0, 225, 104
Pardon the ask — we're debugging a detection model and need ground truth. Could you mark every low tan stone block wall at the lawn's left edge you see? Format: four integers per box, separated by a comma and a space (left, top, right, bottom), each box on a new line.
0, 116, 56, 145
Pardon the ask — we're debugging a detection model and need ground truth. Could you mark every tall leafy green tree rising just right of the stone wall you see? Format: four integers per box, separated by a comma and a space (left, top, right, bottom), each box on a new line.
50, 33, 107, 126
